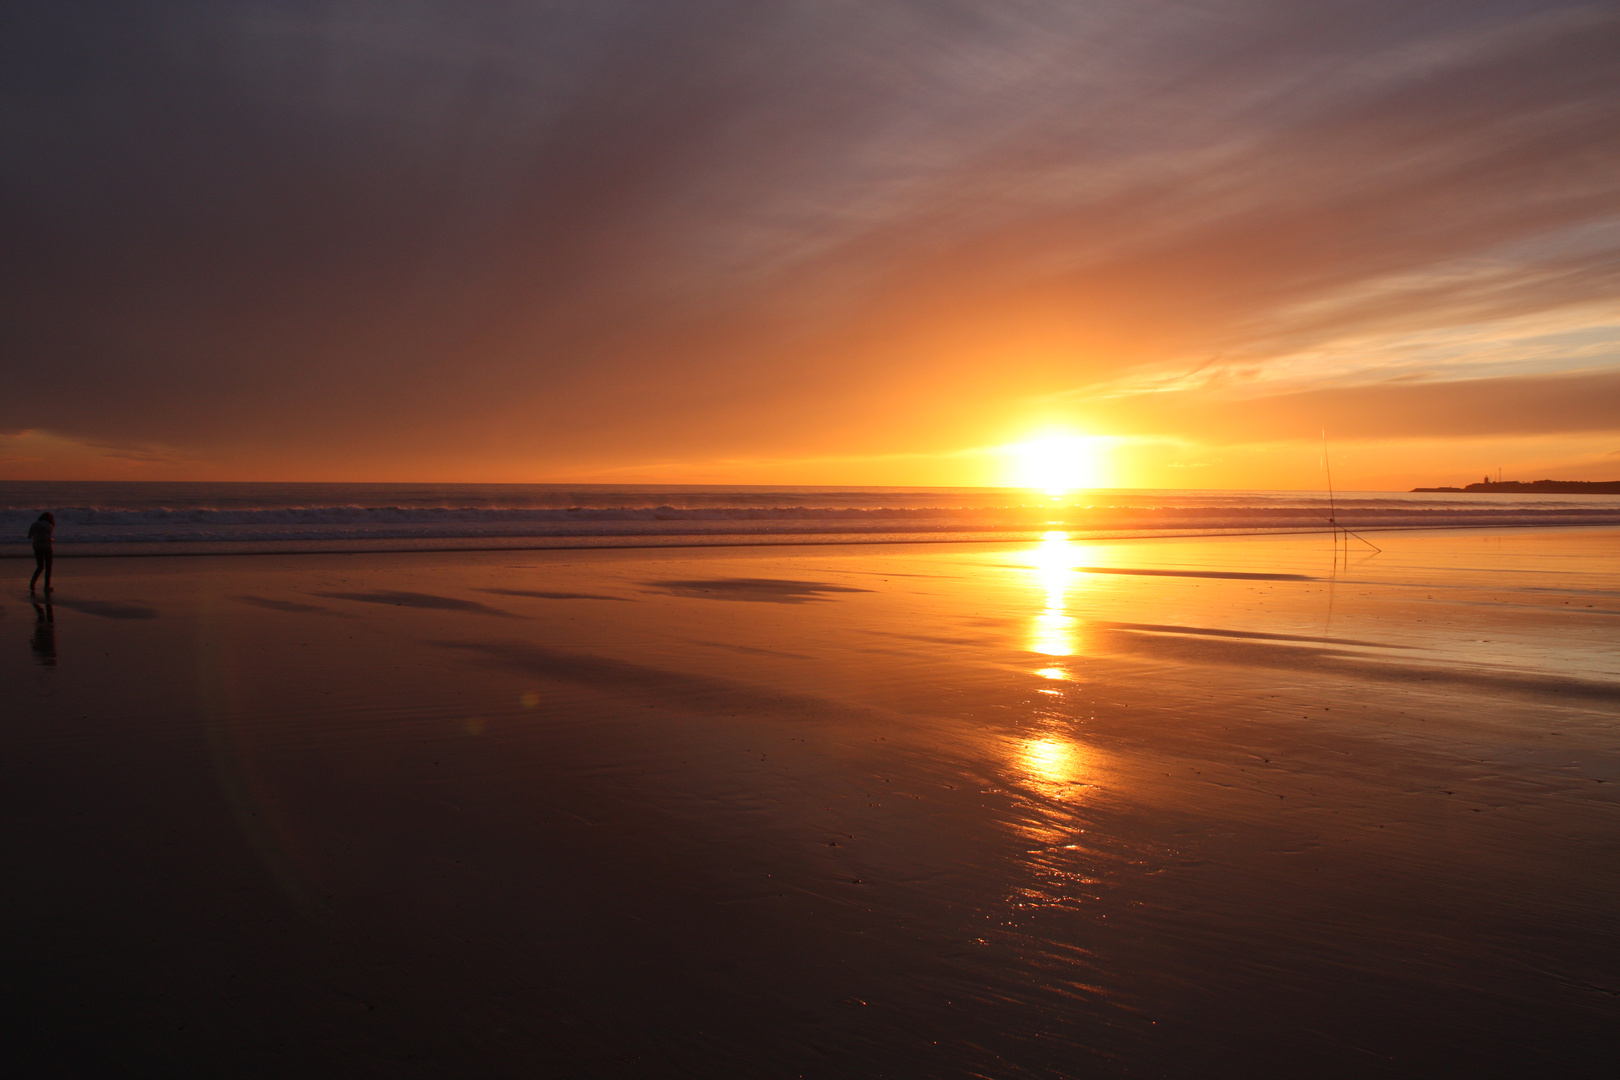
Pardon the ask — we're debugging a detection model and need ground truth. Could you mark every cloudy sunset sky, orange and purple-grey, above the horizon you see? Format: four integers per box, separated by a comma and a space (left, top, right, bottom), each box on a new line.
0, 0, 1620, 489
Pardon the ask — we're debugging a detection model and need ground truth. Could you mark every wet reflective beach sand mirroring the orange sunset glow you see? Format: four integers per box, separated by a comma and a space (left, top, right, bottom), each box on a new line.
0, 529, 1620, 1078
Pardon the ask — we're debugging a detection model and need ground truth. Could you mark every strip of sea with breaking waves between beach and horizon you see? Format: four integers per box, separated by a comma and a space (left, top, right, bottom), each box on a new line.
0, 481, 1620, 555
